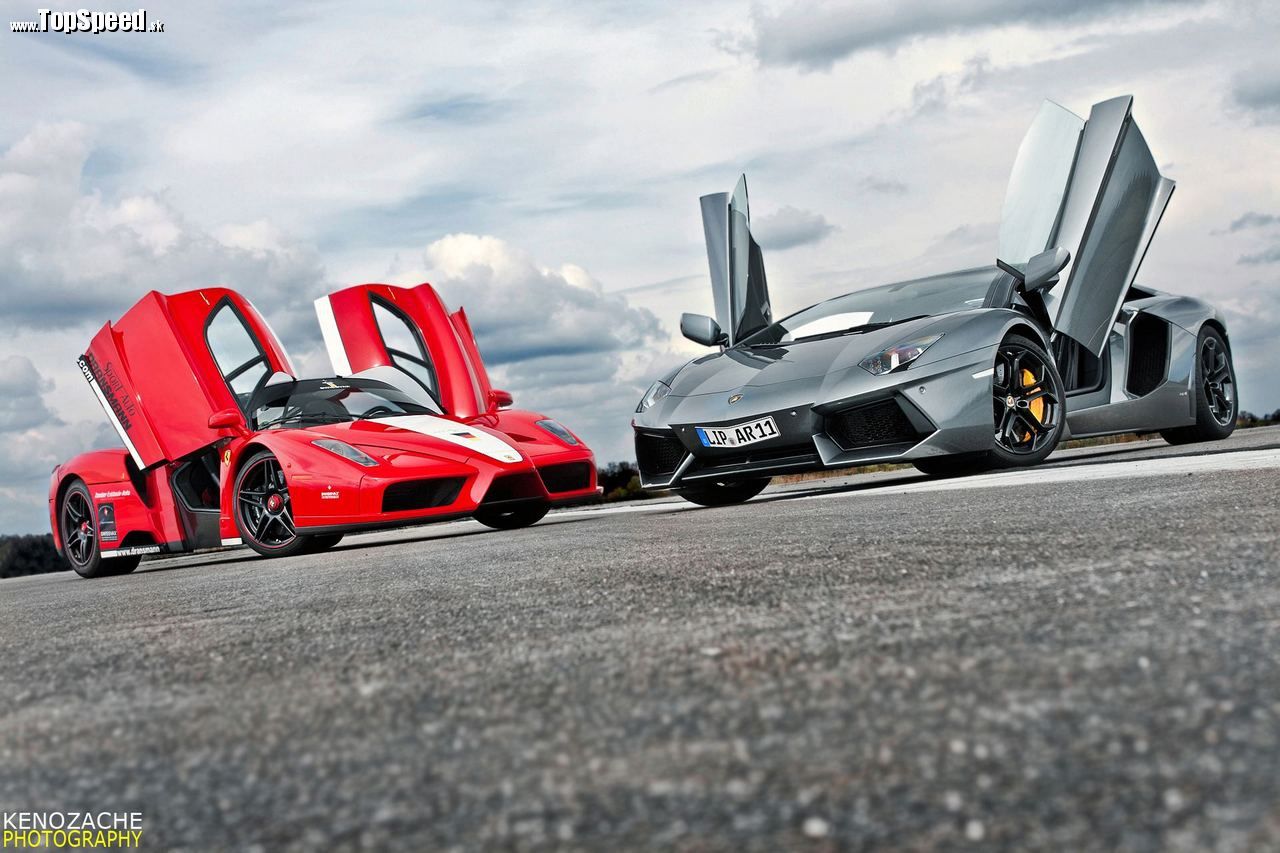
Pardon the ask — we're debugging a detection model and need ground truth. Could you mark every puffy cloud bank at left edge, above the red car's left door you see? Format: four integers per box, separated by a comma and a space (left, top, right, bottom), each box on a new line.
0, 123, 324, 341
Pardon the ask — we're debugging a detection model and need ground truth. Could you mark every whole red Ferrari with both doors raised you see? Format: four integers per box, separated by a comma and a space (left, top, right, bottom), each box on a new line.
49, 284, 598, 578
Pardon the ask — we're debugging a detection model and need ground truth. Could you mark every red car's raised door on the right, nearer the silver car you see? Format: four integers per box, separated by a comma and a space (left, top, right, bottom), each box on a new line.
316, 284, 495, 419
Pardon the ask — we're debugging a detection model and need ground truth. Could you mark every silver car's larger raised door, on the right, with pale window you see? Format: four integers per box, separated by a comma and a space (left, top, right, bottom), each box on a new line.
1000, 95, 1174, 355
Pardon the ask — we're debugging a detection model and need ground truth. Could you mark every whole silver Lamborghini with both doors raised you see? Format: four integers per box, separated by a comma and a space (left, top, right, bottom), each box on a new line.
632, 96, 1236, 505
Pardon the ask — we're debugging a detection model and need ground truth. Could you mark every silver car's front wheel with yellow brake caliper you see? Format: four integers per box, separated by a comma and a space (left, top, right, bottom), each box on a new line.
983, 334, 1066, 467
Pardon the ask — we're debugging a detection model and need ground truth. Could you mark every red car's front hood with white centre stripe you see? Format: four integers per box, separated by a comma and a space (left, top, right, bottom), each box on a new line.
295, 415, 525, 464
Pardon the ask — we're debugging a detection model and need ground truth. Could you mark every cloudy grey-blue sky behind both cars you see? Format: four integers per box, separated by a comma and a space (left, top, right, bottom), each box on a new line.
0, 0, 1280, 532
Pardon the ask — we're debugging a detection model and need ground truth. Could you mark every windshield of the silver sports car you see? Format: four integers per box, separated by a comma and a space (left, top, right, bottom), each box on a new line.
744, 268, 998, 346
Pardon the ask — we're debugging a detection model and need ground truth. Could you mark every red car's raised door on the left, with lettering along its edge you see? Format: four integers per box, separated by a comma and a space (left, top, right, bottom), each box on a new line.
79, 287, 294, 469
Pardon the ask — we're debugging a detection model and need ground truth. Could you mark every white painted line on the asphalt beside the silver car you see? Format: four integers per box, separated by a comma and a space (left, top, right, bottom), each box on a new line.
801, 450, 1280, 501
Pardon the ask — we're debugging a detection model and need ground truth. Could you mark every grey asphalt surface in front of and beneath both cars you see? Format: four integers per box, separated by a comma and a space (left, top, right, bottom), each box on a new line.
0, 429, 1280, 850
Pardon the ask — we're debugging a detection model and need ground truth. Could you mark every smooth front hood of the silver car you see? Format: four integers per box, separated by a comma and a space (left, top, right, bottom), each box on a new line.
671, 318, 938, 397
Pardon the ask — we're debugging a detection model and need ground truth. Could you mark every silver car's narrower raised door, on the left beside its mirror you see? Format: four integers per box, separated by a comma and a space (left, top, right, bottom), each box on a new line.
699, 175, 773, 346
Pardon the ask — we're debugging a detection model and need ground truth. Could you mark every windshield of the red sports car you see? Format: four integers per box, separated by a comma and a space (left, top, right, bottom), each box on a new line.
250, 379, 440, 429
